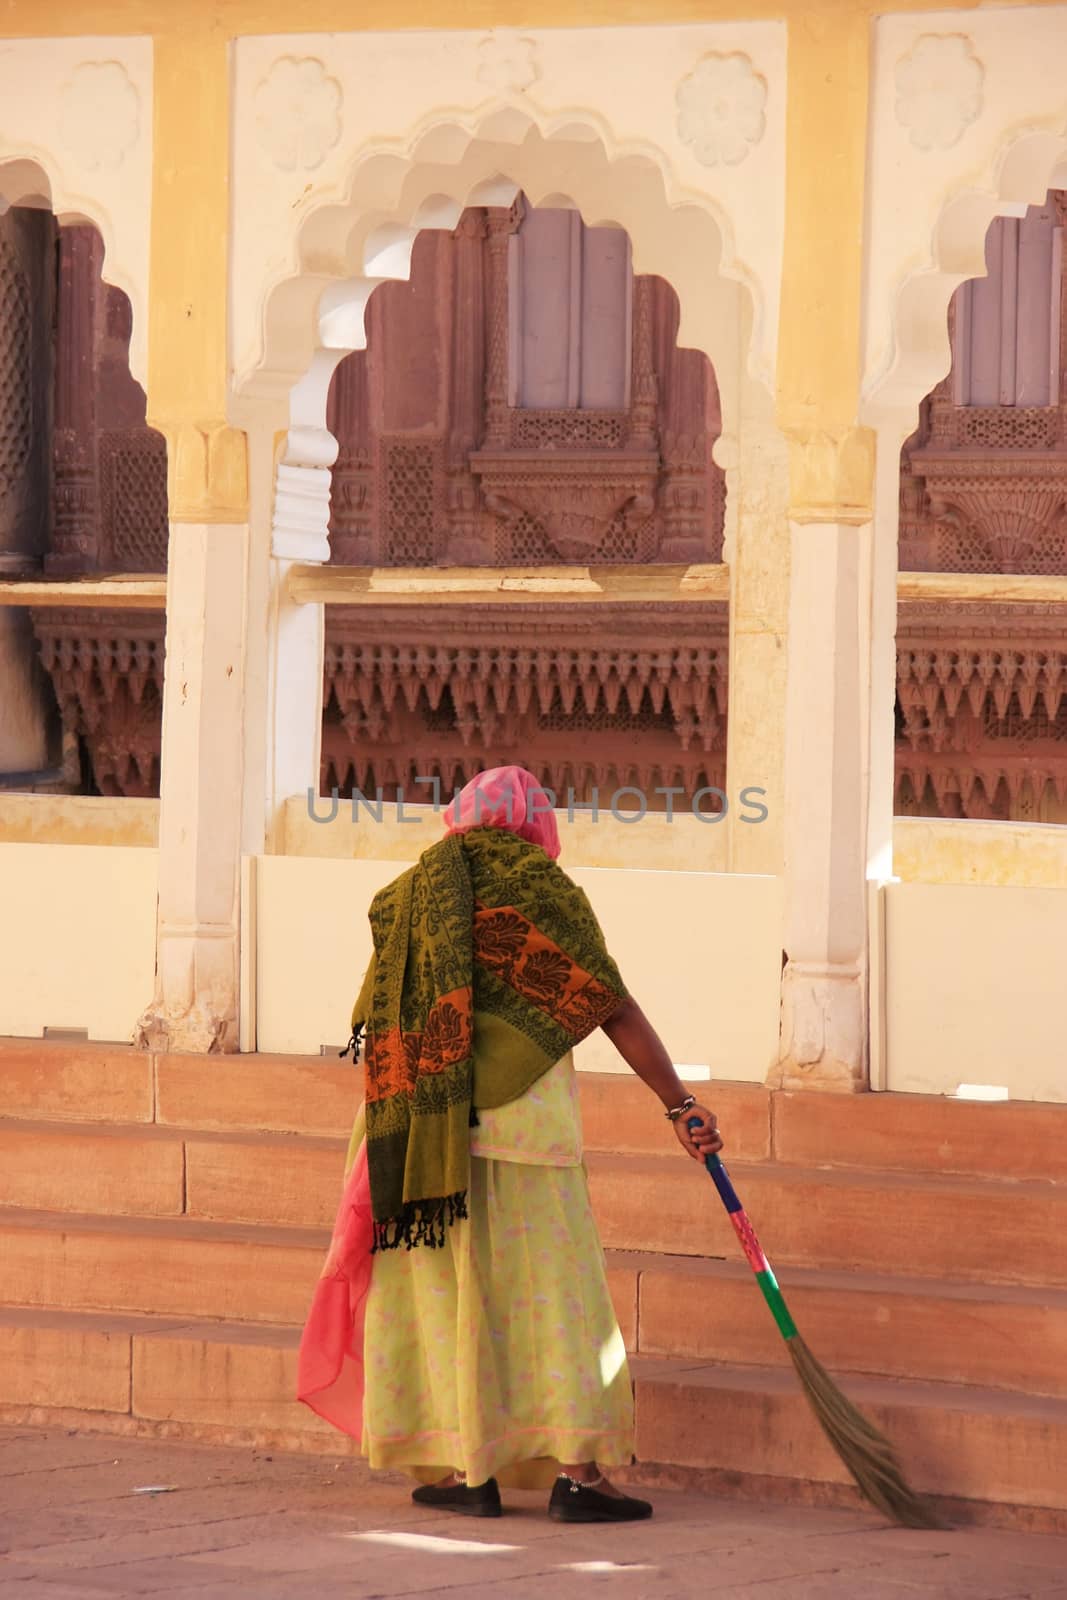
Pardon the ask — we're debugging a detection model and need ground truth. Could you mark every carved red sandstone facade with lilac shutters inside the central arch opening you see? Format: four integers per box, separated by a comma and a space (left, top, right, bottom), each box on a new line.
328, 202, 725, 565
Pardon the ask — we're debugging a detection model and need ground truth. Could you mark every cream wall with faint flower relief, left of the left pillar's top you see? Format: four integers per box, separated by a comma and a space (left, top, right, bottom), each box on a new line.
0, 37, 152, 386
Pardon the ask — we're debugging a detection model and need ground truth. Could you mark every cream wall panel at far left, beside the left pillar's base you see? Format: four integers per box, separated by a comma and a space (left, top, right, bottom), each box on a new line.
0, 845, 158, 1042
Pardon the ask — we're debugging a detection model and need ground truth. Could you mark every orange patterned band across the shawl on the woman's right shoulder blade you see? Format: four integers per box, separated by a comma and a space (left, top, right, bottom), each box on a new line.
474, 906, 619, 1038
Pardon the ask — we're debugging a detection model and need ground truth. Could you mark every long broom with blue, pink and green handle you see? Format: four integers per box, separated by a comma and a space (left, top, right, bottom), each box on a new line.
688, 1117, 944, 1528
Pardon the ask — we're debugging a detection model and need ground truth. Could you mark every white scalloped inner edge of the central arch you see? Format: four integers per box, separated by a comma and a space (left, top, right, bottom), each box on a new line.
235, 109, 769, 432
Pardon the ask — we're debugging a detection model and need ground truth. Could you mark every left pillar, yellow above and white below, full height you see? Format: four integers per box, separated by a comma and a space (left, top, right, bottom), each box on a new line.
138, 31, 248, 1051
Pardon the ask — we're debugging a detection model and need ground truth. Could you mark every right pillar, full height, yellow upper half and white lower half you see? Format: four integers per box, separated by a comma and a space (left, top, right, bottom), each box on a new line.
777, 6, 893, 1090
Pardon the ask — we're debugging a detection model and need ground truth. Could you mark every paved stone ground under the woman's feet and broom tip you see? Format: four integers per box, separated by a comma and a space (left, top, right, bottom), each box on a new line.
0, 1427, 1067, 1600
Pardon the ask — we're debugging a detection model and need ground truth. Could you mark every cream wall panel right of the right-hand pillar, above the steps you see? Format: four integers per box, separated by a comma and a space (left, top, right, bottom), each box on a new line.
885, 883, 1067, 1107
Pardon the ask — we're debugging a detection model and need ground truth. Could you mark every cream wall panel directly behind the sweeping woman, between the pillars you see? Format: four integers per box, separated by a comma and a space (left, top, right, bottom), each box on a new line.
256, 856, 781, 1082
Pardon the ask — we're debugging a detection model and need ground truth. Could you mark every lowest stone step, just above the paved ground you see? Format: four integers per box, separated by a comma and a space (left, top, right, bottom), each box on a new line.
0, 1310, 1067, 1515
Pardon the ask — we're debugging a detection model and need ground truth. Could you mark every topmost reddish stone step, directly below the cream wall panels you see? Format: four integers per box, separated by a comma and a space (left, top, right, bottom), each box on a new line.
0, 1040, 1067, 1182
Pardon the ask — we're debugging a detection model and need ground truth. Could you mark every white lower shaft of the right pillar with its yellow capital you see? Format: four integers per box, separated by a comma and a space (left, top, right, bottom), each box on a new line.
779, 429, 896, 1090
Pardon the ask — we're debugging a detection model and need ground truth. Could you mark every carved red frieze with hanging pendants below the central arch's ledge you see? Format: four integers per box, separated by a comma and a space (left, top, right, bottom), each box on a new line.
323, 603, 729, 800
